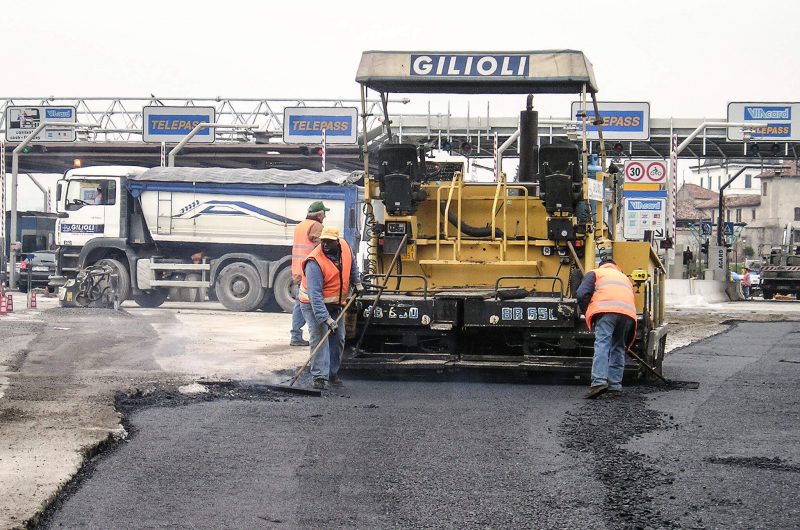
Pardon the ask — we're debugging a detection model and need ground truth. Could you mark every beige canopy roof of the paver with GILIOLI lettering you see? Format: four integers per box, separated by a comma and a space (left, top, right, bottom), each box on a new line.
356, 50, 597, 94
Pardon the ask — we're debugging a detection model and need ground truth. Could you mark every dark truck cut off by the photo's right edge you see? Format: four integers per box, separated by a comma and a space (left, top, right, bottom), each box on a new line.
760, 223, 800, 300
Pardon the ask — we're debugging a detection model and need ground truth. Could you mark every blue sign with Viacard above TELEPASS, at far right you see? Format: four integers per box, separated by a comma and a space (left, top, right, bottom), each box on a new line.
728, 102, 800, 142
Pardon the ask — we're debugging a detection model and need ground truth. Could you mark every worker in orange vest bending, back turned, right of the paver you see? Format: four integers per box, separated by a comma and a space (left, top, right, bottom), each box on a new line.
575, 258, 637, 399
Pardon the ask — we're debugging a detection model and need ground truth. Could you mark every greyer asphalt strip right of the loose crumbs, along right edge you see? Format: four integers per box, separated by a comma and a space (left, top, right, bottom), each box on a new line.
640, 321, 800, 529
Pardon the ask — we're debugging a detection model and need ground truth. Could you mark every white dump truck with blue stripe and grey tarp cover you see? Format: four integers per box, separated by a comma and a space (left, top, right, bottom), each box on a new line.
51, 166, 361, 311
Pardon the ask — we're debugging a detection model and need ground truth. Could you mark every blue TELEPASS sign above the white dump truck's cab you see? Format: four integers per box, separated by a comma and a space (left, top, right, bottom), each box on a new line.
142, 106, 216, 144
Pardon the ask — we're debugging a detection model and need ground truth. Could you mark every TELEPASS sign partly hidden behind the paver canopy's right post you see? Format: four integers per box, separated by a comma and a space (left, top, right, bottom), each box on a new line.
570, 101, 650, 140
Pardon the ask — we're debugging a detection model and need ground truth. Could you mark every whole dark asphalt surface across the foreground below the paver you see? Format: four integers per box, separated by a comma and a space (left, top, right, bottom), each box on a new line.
42, 322, 800, 528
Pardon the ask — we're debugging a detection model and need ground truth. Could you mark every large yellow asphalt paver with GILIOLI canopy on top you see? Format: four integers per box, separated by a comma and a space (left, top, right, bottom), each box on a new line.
343, 50, 666, 374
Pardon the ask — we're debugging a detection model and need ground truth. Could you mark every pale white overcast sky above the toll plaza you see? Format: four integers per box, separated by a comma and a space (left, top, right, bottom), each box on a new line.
0, 0, 800, 207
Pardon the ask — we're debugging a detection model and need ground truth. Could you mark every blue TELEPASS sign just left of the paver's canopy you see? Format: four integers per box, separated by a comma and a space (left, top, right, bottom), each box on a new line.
283, 107, 358, 144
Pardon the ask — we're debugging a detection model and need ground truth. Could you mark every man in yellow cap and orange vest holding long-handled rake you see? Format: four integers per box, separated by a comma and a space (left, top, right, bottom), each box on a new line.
297, 226, 364, 389
